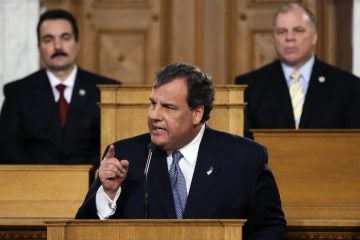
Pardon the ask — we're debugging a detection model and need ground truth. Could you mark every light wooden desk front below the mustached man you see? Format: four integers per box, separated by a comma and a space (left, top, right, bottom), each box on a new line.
0, 165, 91, 222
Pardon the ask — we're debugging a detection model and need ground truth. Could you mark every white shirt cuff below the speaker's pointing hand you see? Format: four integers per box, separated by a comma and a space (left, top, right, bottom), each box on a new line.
96, 186, 121, 220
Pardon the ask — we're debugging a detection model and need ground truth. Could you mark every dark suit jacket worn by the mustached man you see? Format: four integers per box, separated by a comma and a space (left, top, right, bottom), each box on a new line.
0, 66, 119, 165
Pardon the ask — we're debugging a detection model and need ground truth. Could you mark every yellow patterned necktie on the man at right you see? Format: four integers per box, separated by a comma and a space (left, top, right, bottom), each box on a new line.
289, 71, 305, 129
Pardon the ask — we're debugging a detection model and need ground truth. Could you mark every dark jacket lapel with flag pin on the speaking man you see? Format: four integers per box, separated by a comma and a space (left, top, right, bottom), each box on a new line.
184, 128, 221, 218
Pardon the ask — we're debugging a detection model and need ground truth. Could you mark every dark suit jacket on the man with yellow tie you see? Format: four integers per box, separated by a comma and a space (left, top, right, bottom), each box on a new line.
236, 58, 360, 137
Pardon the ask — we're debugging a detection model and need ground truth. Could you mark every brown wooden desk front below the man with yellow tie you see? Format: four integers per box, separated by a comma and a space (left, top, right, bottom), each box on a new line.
252, 129, 360, 220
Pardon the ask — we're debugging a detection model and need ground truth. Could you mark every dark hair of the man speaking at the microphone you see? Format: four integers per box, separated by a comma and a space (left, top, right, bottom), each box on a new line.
153, 63, 214, 122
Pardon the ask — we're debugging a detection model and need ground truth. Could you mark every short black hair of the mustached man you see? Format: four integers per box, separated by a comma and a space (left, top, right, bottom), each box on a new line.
36, 9, 79, 44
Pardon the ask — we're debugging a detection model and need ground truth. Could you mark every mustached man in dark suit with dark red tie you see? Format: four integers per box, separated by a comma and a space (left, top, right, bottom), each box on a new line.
0, 10, 120, 166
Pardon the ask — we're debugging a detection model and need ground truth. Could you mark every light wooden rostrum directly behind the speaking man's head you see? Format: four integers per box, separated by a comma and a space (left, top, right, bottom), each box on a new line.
98, 85, 245, 152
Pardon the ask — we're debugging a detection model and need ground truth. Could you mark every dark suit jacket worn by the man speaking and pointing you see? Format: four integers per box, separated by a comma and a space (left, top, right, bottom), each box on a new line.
76, 128, 286, 240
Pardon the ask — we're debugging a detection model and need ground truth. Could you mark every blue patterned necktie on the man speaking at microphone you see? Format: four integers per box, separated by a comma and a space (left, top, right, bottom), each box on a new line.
169, 151, 187, 218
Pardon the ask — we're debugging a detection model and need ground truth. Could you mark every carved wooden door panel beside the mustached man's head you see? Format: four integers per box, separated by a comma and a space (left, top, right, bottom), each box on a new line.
48, 0, 165, 84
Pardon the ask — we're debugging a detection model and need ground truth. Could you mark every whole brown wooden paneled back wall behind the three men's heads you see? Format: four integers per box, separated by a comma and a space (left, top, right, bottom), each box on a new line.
44, 0, 351, 84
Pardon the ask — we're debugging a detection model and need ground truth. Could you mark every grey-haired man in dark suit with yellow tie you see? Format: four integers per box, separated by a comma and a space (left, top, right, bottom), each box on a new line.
236, 3, 360, 137
